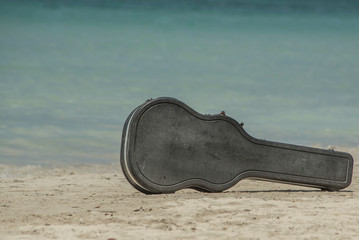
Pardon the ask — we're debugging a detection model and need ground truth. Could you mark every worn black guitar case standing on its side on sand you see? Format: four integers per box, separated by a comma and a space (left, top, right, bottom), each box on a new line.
121, 97, 353, 194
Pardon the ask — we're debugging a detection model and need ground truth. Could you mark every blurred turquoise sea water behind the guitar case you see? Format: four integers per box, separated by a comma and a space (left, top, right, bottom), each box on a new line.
0, 0, 359, 165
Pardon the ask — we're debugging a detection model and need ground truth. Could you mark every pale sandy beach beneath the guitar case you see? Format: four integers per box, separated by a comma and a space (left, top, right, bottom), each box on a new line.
0, 148, 359, 240
